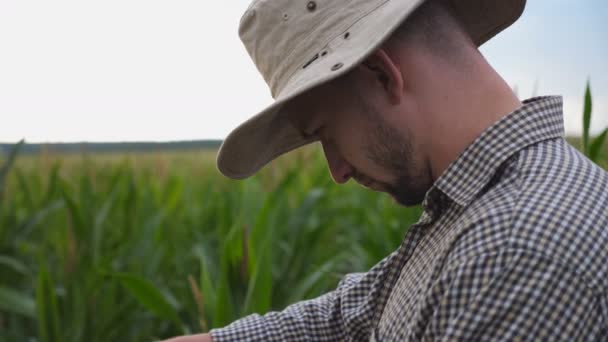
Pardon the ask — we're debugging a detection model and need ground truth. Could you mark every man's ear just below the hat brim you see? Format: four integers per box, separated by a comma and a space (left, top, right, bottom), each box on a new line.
361, 48, 404, 104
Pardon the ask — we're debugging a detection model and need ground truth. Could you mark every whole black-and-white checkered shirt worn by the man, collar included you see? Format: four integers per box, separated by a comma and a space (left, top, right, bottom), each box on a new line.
211, 97, 608, 342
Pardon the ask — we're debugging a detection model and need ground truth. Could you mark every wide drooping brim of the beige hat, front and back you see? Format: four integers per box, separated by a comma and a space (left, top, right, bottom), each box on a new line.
217, 0, 525, 179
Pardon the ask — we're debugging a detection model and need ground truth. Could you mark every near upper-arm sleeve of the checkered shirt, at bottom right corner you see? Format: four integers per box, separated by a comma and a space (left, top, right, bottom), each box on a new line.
422, 251, 608, 341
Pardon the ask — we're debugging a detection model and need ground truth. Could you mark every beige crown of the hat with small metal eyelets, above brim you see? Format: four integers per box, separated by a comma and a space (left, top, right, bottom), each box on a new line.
239, 0, 389, 98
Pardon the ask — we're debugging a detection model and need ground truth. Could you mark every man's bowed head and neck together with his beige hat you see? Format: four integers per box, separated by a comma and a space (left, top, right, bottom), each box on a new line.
218, 0, 525, 205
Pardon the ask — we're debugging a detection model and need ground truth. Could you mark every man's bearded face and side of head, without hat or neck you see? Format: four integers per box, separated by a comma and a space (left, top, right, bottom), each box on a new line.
285, 1, 480, 205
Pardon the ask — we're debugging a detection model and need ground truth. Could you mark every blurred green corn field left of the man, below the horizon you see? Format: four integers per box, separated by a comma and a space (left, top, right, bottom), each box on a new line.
0, 149, 419, 341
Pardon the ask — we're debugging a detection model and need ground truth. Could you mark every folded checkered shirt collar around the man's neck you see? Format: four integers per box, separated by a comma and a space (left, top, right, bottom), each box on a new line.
423, 96, 564, 207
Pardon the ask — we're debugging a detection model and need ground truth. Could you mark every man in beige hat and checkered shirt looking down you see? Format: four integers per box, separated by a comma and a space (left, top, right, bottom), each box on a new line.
169, 0, 608, 342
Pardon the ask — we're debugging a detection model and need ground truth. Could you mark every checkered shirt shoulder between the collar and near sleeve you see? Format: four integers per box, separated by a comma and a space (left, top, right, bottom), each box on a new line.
450, 139, 608, 289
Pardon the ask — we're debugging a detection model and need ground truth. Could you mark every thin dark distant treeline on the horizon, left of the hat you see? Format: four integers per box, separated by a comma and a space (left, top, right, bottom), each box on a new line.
0, 140, 222, 154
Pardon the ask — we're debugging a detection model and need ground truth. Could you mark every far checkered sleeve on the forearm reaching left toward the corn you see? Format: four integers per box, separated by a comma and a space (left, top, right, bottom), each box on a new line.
210, 252, 396, 342
